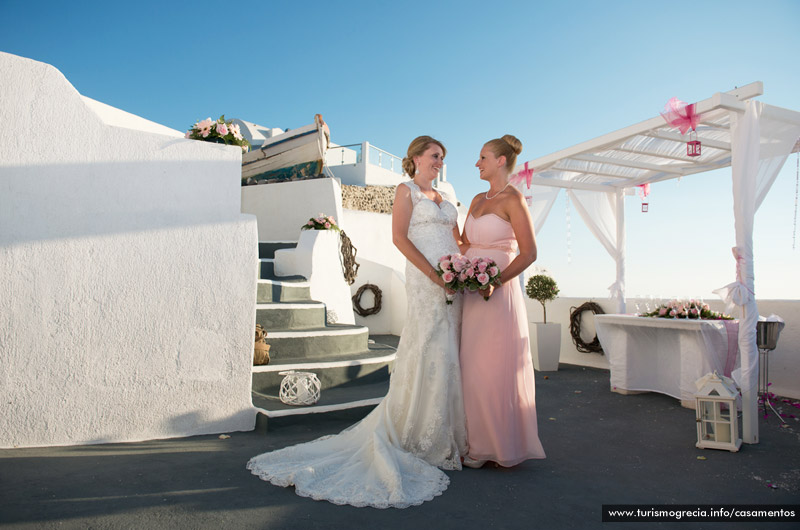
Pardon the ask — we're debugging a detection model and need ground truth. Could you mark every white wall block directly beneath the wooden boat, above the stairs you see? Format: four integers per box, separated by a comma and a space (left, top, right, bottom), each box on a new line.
241, 178, 342, 241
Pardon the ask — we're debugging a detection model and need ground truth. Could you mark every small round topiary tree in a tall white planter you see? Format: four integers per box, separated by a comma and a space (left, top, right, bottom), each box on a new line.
525, 274, 561, 372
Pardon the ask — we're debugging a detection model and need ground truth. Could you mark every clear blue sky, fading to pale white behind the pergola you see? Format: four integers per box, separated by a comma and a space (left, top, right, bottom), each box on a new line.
0, 0, 800, 299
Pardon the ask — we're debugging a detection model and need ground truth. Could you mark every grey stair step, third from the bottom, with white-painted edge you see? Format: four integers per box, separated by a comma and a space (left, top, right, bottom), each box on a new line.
267, 324, 369, 363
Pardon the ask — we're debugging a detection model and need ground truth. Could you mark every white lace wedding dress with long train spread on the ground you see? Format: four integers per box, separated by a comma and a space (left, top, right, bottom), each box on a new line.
247, 182, 466, 508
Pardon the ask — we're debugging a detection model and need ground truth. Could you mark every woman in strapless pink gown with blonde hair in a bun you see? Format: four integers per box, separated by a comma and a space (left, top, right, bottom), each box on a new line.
460, 134, 545, 467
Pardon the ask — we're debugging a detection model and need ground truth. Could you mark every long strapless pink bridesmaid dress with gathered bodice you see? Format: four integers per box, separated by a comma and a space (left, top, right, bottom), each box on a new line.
460, 213, 545, 467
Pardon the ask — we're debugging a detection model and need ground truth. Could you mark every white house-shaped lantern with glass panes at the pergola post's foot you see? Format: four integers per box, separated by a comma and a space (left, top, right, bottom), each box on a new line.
694, 372, 742, 452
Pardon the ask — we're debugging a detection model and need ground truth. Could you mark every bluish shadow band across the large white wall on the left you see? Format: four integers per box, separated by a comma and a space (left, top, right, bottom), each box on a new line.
0, 159, 241, 246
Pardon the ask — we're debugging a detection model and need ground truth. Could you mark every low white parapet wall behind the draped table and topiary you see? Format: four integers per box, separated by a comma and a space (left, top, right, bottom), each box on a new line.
526, 297, 800, 399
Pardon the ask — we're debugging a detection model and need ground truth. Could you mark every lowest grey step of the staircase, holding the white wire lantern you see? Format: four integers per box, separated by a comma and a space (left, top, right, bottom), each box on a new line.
252, 380, 389, 432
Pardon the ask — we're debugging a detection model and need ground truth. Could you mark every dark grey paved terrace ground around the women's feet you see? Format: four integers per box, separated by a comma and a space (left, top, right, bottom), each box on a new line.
0, 365, 800, 530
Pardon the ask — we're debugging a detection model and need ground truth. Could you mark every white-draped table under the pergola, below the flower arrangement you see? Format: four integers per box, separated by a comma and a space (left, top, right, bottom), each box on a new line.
594, 315, 739, 408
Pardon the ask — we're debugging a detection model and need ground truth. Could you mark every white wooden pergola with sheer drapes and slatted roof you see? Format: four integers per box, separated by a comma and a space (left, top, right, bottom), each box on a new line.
512, 82, 800, 443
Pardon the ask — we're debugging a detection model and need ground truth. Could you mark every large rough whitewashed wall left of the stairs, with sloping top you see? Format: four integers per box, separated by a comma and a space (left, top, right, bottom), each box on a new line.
0, 53, 257, 447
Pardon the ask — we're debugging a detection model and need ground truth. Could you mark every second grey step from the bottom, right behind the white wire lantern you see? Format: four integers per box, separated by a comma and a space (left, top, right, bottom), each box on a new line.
252, 344, 395, 396
